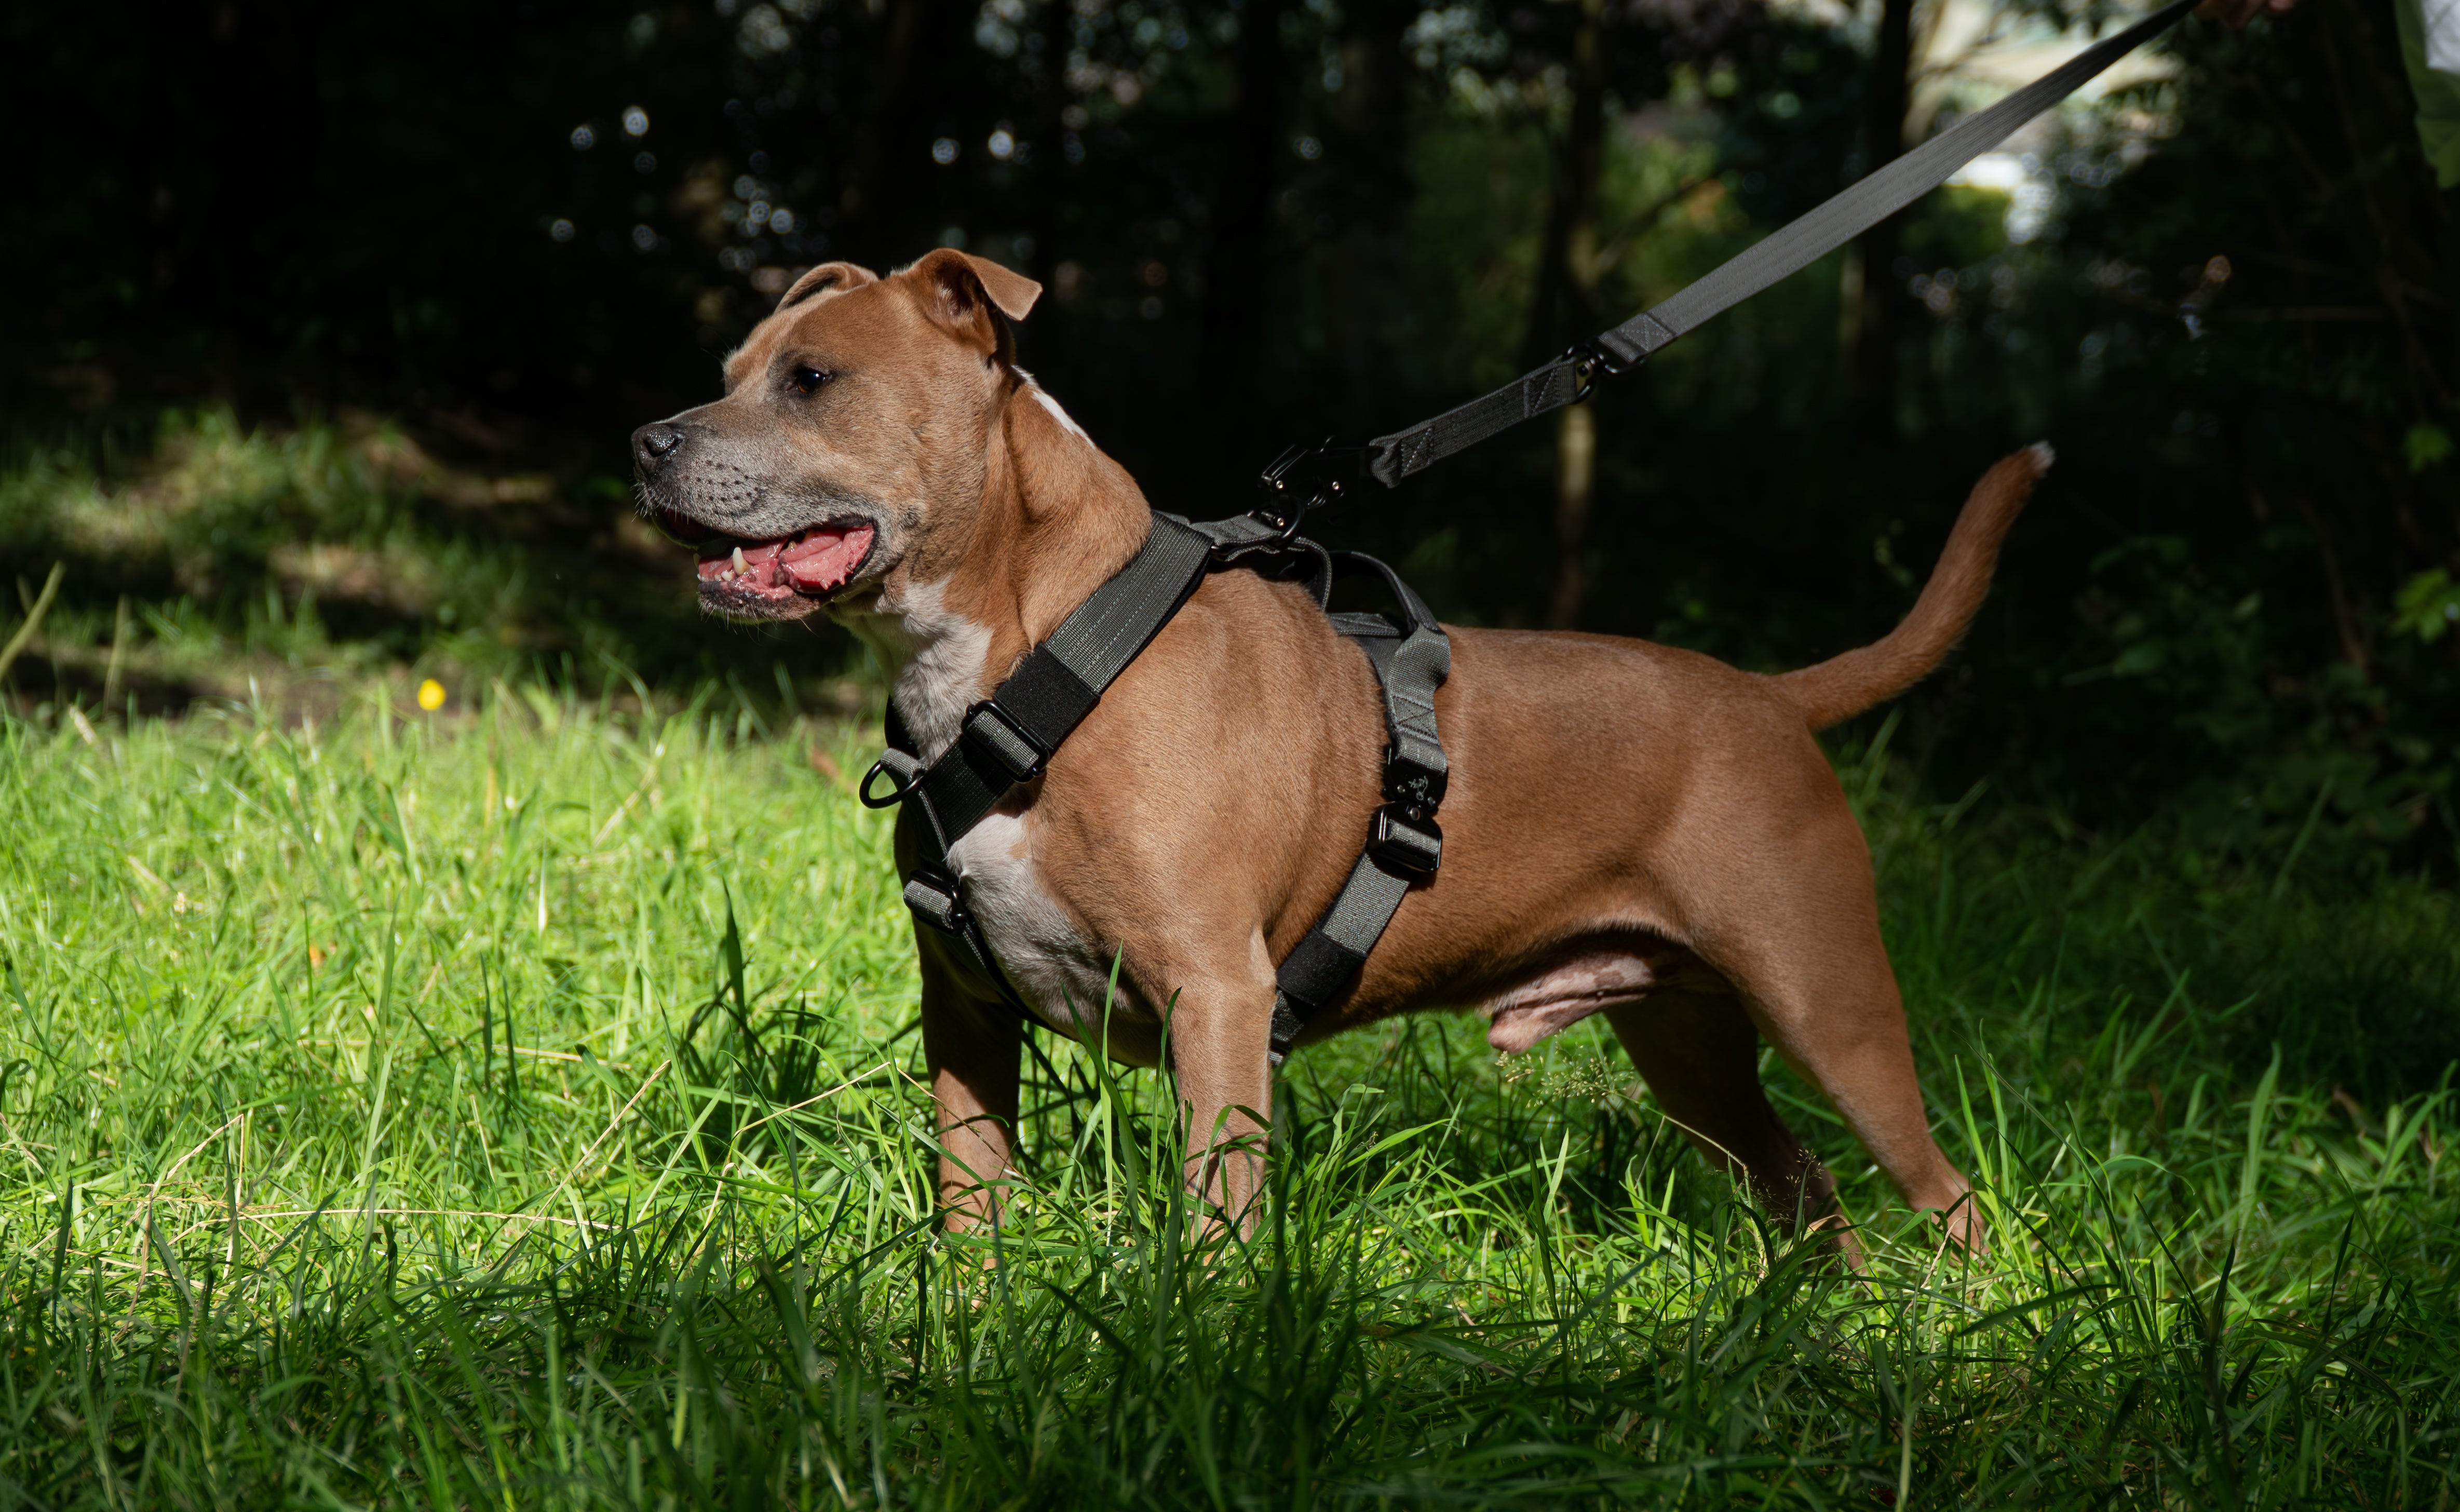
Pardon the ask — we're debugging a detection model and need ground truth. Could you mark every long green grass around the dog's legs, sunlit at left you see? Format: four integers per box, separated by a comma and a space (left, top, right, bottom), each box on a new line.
0, 686, 2460, 1509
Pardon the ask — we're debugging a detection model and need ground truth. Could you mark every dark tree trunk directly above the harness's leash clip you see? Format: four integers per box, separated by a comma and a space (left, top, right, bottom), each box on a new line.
1196, 0, 1284, 477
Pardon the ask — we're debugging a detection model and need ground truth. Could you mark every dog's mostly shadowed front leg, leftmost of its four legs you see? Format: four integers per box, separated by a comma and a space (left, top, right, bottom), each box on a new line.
923, 949, 1023, 1229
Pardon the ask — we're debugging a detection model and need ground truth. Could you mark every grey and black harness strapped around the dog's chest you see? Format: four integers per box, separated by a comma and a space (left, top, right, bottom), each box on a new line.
861, 511, 1451, 1064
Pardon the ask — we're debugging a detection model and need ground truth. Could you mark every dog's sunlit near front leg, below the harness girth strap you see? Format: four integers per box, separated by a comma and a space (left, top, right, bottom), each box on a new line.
1169, 939, 1272, 1234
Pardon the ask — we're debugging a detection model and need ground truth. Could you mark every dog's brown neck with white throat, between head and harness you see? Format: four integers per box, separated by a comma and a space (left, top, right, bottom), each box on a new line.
859, 384, 1151, 760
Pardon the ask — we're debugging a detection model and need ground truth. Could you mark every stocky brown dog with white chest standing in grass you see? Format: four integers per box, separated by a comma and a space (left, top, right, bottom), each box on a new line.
634, 251, 2049, 1241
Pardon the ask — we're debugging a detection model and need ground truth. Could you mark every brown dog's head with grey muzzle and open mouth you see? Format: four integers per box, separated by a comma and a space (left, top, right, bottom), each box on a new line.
632, 248, 1040, 619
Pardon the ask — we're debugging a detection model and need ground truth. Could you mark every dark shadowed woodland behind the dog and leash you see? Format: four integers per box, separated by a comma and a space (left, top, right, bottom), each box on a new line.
0, 0, 2460, 873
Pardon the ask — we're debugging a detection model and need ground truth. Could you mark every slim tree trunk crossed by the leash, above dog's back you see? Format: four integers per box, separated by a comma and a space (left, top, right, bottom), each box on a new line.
1525, 0, 1606, 629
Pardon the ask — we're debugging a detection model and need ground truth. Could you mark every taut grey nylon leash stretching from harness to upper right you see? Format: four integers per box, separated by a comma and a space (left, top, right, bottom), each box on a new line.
1368, 0, 2199, 492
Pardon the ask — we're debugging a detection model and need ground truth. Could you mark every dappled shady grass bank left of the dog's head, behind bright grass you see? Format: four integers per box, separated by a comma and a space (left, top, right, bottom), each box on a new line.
0, 411, 871, 716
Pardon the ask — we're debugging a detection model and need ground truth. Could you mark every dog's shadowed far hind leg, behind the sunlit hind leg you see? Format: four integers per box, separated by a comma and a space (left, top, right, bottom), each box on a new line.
1606, 986, 1853, 1254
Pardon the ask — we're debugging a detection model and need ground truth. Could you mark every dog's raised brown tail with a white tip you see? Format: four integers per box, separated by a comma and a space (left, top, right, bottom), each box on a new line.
1774, 442, 2051, 730
